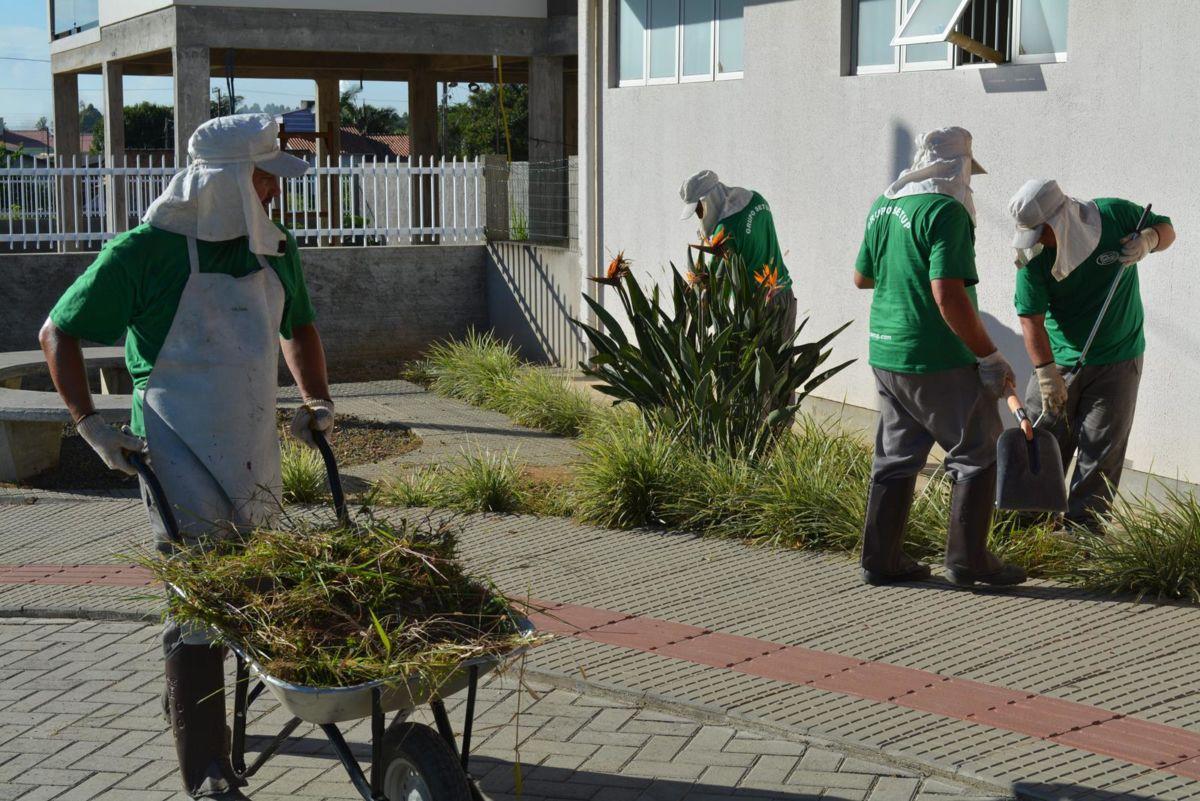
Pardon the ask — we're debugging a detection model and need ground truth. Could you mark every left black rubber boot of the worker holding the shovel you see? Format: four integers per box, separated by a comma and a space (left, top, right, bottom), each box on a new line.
862, 476, 930, 586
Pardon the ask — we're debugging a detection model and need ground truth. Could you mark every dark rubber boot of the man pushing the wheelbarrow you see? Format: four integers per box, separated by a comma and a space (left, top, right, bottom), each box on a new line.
166, 645, 248, 801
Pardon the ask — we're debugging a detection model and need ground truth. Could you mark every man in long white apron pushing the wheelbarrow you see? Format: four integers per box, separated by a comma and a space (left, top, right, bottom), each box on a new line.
41, 114, 334, 800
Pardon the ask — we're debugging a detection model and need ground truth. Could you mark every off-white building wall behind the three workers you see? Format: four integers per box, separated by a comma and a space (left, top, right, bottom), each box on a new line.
590, 0, 1200, 481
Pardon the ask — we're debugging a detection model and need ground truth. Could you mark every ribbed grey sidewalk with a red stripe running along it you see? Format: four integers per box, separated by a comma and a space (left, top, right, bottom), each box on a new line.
0, 383, 1200, 801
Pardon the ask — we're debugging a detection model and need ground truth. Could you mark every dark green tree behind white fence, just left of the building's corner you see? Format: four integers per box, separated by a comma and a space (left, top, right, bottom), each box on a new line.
445, 84, 529, 161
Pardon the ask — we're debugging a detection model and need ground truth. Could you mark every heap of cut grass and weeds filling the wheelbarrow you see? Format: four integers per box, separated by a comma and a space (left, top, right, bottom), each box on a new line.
144, 519, 527, 687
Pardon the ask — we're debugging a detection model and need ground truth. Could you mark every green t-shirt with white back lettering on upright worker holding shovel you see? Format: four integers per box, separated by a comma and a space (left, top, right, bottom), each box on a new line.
854, 194, 979, 373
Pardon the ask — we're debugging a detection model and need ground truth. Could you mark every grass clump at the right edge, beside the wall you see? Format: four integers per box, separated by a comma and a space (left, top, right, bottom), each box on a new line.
1068, 484, 1200, 603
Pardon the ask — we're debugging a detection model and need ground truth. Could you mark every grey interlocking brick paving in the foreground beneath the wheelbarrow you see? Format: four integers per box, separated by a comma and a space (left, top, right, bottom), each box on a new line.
0, 619, 1003, 801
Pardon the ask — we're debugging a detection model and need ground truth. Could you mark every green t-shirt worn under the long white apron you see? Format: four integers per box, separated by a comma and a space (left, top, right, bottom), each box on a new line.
50, 223, 316, 435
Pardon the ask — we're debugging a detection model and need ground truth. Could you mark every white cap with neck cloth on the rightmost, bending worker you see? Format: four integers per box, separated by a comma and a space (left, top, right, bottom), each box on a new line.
1008, 179, 1100, 281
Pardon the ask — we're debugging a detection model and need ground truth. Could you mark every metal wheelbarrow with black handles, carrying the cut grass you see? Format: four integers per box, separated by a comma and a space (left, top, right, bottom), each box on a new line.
130, 432, 533, 801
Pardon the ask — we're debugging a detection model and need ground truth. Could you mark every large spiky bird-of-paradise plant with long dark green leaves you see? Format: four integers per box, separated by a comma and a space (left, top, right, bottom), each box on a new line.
575, 247, 851, 460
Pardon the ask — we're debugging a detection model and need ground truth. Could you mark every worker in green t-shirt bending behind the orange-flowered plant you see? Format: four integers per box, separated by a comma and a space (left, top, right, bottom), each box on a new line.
679, 170, 796, 333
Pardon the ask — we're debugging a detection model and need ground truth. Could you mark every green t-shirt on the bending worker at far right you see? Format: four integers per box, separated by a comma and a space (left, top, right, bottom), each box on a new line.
1015, 198, 1171, 366
